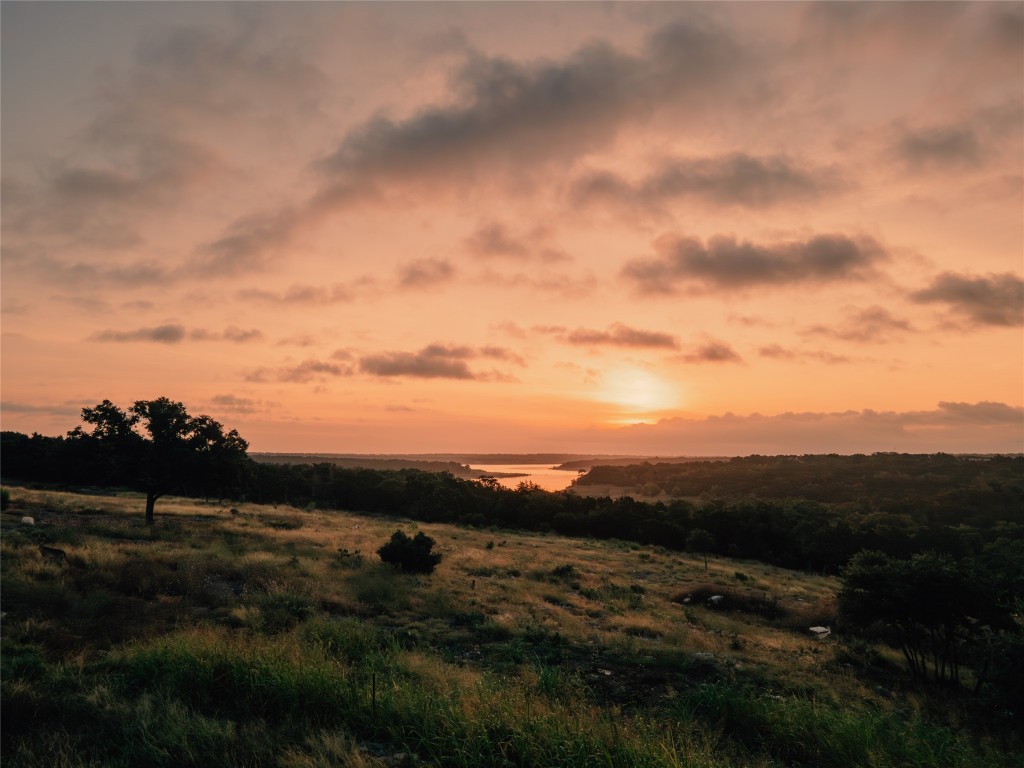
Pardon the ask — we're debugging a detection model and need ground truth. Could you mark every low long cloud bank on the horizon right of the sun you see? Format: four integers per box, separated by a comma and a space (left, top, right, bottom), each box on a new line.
608, 401, 1024, 456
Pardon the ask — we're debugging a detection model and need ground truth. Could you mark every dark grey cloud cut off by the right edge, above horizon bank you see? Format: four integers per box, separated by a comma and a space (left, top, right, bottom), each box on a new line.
910, 272, 1024, 326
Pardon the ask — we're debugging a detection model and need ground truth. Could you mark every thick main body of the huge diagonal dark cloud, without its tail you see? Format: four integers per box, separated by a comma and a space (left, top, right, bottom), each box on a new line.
321, 23, 750, 186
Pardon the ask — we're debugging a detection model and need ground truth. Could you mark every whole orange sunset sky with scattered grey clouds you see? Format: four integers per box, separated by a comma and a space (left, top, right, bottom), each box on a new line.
0, 0, 1024, 456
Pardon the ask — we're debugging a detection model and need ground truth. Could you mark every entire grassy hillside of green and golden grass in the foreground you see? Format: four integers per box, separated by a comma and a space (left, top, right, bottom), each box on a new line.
0, 487, 1020, 768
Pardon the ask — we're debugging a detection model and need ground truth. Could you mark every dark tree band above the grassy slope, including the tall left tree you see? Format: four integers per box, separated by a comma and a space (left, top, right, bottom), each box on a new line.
2, 409, 1024, 573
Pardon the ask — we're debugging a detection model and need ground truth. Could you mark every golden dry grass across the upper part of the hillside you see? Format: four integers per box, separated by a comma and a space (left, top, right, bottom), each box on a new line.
3, 488, 837, 674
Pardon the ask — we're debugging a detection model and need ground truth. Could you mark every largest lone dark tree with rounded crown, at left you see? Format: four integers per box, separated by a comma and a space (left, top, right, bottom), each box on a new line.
68, 397, 249, 525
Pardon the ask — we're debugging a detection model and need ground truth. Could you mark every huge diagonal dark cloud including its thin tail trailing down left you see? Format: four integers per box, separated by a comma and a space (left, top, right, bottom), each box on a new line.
197, 23, 758, 274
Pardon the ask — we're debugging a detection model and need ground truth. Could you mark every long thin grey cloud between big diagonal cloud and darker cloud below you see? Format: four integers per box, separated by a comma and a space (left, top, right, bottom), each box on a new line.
570, 153, 844, 212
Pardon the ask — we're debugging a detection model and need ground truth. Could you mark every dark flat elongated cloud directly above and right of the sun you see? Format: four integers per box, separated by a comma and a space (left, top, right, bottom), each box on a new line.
623, 234, 887, 293
